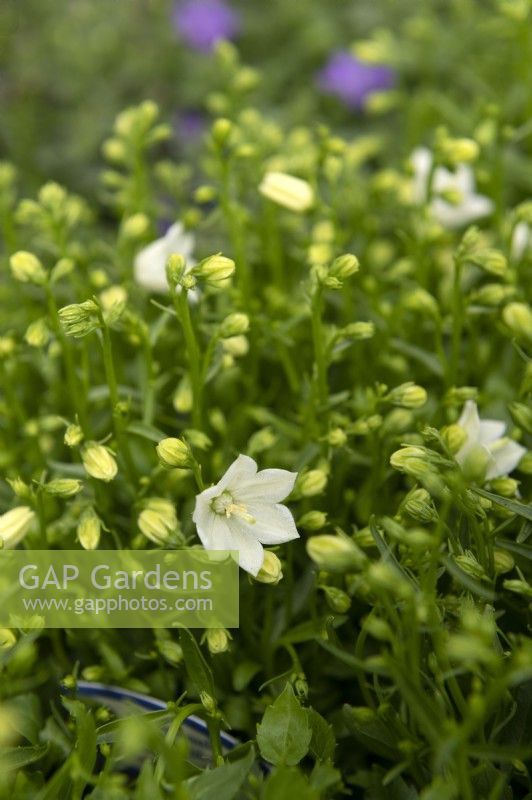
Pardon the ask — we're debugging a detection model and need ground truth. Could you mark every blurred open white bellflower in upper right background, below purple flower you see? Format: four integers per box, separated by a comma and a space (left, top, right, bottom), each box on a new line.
410, 147, 493, 228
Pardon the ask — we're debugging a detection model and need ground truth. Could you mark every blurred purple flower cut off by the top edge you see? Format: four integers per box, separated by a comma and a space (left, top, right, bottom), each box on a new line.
173, 0, 240, 53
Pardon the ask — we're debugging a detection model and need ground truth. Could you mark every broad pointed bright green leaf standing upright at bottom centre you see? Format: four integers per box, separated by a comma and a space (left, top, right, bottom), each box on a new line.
257, 683, 312, 766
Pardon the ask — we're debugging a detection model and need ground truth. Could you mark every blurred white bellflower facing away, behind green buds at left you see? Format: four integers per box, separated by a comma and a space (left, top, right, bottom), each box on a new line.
134, 222, 195, 293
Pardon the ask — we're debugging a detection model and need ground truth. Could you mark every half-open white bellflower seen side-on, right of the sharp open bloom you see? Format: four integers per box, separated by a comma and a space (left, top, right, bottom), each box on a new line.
455, 400, 526, 481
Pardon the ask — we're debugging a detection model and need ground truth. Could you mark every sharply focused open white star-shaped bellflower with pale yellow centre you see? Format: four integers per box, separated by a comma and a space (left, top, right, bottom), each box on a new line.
192, 455, 299, 575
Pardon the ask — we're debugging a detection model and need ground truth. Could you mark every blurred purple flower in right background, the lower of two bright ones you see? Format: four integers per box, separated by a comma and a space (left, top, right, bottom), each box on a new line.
318, 50, 395, 109
